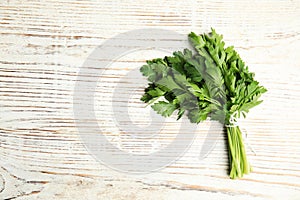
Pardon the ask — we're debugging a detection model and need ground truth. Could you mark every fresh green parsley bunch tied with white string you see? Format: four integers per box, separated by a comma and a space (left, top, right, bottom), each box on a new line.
140, 29, 267, 179
